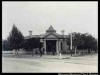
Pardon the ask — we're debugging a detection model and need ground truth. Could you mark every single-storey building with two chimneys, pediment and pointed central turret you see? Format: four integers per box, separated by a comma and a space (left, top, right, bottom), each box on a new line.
26, 26, 68, 54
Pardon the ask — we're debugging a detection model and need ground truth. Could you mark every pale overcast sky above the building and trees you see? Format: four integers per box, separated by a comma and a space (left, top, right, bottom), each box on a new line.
2, 1, 98, 39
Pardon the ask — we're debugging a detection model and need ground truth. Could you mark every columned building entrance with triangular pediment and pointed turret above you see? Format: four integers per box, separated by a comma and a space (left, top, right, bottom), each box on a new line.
41, 26, 66, 54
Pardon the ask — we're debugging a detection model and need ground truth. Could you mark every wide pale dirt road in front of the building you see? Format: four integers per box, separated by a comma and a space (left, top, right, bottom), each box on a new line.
2, 54, 98, 73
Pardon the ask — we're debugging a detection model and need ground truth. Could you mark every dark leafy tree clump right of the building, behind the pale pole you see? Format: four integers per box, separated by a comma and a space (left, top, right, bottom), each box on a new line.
67, 32, 97, 53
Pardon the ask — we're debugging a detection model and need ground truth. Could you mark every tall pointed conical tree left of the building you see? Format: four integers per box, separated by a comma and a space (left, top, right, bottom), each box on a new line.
7, 25, 24, 55
